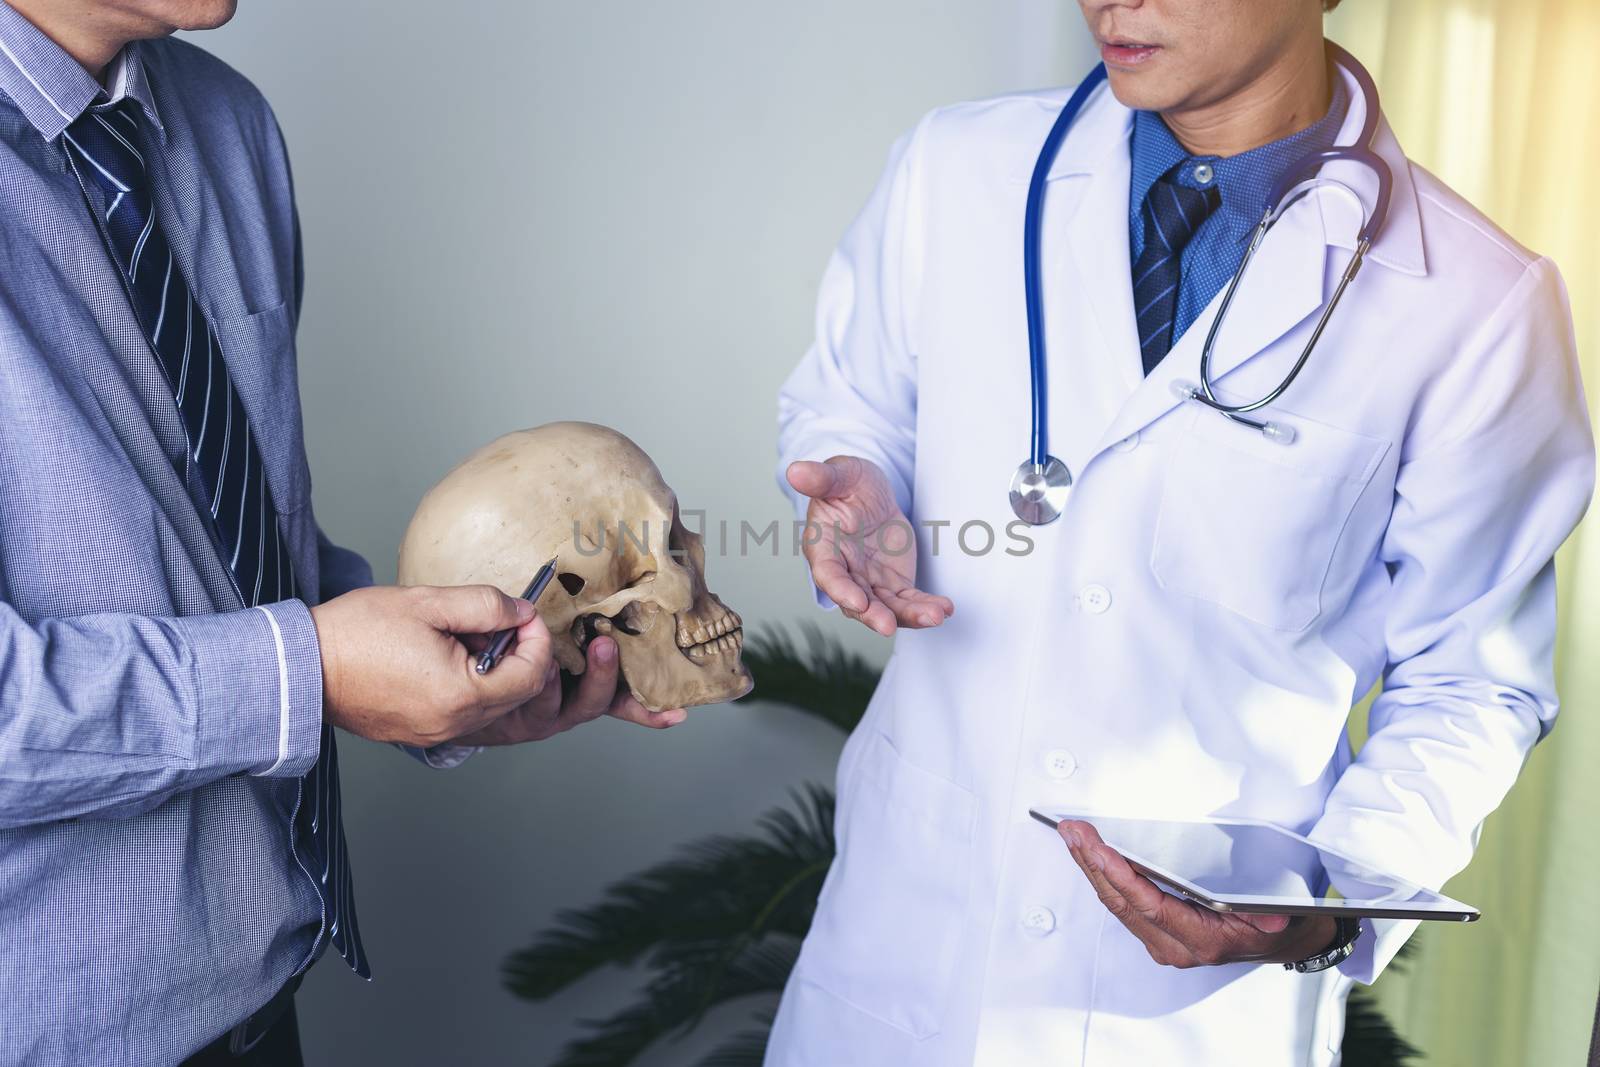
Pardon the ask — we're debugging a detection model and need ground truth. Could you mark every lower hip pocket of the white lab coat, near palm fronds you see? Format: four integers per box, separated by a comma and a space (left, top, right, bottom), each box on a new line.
798, 726, 976, 1038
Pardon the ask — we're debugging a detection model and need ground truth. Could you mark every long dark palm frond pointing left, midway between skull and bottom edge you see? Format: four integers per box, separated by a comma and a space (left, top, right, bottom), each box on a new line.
504, 787, 834, 1014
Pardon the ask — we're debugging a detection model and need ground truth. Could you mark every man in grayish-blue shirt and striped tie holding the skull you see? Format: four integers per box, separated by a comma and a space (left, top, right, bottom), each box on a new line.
0, 0, 683, 1067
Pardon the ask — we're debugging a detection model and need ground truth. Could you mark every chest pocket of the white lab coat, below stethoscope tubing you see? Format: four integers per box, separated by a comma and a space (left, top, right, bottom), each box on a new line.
1150, 408, 1389, 632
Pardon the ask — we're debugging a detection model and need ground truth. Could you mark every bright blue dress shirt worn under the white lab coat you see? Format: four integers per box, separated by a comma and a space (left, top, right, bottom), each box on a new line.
1128, 78, 1349, 344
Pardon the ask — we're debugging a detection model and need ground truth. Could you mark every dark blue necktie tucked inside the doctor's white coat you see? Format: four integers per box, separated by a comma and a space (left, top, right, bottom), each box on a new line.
1133, 163, 1222, 374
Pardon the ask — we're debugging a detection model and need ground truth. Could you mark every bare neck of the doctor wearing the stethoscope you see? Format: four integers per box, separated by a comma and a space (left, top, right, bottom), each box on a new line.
1162, 35, 1333, 157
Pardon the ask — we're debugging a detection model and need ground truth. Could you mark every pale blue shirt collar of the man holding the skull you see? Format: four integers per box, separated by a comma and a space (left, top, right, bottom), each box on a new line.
0, 0, 166, 141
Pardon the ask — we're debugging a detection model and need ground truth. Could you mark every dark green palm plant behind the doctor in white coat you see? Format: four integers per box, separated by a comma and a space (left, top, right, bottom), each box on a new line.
504, 627, 1419, 1067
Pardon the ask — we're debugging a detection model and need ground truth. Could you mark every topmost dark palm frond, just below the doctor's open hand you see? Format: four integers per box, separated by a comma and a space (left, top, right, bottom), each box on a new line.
741, 622, 880, 733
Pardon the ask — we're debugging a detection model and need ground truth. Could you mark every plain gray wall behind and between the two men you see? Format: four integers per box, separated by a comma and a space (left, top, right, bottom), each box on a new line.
184, 0, 1090, 1065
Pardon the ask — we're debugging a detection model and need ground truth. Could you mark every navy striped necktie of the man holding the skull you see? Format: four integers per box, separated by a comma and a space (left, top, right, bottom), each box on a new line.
62, 99, 371, 977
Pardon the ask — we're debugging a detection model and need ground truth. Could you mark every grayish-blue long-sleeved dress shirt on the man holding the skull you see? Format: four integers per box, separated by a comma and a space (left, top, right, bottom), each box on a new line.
0, 2, 371, 1067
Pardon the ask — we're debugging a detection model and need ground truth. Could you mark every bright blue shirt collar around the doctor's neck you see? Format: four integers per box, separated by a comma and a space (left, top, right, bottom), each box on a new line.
1130, 78, 1350, 237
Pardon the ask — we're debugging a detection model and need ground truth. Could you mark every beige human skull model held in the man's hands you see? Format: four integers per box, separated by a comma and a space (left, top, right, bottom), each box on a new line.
400, 422, 752, 710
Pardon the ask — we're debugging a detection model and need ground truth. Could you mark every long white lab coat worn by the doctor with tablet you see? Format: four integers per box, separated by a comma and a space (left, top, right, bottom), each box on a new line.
768, 62, 1594, 1067
